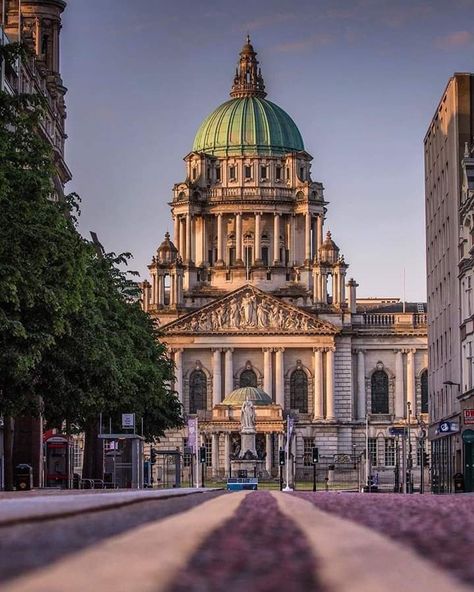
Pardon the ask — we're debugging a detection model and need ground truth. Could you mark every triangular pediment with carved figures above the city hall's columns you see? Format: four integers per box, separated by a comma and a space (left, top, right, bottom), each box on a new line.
162, 285, 339, 335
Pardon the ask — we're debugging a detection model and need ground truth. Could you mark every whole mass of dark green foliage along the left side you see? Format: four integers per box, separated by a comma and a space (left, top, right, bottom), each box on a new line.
0, 69, 181, 448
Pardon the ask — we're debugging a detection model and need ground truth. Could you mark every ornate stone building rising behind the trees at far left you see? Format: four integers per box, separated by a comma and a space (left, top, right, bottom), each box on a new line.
0, 0, 71, 488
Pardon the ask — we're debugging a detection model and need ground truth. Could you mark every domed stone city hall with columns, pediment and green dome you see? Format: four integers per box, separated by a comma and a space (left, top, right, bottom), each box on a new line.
142, 39, 428, 478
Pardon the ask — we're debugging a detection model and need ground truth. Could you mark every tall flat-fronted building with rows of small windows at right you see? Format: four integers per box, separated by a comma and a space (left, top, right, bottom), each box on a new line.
424, 73, 474, 492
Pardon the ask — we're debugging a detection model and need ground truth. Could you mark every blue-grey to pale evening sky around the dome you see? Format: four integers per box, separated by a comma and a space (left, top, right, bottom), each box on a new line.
61, 0, 474, 302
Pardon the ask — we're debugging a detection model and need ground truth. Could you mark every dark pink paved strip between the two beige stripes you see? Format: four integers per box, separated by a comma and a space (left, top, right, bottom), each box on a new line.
170, 491, 322, 592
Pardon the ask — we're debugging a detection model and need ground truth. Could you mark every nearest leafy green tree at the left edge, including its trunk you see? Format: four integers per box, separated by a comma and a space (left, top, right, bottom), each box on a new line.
0, 84, 86, 488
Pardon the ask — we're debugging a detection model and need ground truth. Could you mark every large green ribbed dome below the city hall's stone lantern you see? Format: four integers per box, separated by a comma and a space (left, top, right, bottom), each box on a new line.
193, 96, 304, 156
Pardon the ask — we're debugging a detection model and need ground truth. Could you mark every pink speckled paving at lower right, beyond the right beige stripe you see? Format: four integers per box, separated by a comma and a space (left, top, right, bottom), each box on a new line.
295, 492, 474, 584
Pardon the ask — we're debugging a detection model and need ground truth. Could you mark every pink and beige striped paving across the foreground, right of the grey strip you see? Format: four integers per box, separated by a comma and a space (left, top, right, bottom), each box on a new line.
0, 490, 474, 592
